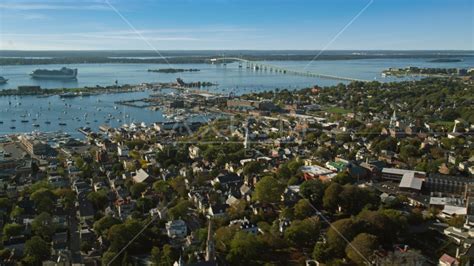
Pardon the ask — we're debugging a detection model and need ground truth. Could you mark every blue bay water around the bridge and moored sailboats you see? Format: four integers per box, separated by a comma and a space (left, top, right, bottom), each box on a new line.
0, 57, 474, 135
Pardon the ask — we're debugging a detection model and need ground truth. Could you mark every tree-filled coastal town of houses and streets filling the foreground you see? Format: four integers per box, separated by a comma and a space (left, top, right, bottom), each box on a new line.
0, 73, 474, 265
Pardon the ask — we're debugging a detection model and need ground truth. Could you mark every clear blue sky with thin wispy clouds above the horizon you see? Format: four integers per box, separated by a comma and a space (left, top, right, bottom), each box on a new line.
0, 0, 474, 50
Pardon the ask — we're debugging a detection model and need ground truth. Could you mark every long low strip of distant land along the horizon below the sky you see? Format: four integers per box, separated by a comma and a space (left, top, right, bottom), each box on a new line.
0, 50, 473, 65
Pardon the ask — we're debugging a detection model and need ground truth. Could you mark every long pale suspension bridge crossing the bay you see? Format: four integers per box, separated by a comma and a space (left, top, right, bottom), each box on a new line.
210, 57, 368, 82
